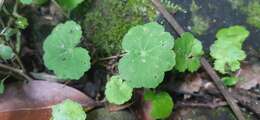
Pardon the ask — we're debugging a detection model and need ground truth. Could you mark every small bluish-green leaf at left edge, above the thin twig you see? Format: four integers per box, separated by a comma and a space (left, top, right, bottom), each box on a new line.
0, 44, 14, 60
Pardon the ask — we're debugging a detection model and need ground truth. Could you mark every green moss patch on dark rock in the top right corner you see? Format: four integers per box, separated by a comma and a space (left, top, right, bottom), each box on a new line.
243, 0, 260, 28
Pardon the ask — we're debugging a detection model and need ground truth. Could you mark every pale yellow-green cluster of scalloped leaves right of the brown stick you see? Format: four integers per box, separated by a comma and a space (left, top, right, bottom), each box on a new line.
210, 26, 249, 73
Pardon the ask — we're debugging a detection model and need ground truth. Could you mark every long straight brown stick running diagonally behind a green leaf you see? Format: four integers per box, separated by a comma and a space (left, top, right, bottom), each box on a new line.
151, 0, 245, 120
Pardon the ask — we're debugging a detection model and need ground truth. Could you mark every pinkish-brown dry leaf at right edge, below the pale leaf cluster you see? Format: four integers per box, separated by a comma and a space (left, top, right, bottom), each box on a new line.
236, 64, 260, 90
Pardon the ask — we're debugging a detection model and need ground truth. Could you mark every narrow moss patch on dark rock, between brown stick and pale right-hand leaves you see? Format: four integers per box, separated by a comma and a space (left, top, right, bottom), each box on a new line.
190, 0, 209, 35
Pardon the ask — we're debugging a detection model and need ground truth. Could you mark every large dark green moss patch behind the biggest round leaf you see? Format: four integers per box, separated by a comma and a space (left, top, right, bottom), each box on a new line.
84, 0, 156, 56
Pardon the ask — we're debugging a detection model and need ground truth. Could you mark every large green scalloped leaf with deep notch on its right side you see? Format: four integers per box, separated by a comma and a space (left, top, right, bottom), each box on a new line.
43, 21, 90, 79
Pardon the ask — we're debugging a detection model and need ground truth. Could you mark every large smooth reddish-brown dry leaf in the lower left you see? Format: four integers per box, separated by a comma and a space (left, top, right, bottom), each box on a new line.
0, 81, 95, 120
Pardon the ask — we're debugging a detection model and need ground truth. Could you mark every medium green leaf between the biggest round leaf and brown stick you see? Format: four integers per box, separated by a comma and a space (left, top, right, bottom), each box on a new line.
174, 32, 203, 72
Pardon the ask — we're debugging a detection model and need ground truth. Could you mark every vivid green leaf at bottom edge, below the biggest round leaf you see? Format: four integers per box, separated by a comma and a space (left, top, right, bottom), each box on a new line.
144, 92, 174, 119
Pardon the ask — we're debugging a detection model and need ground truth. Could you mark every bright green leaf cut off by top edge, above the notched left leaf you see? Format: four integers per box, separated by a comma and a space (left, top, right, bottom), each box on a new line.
56, 0, 84, 11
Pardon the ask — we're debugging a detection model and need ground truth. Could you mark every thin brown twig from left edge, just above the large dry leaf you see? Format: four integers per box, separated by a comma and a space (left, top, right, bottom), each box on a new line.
0, 63, 33, 81
